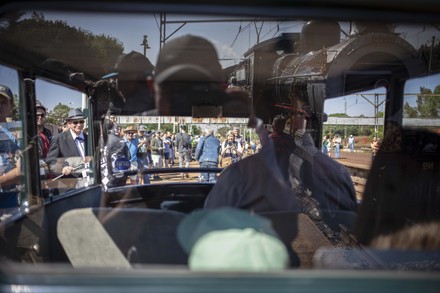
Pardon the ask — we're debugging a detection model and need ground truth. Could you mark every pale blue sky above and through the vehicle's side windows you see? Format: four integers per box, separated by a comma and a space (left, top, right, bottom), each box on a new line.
0, 12, 440, 116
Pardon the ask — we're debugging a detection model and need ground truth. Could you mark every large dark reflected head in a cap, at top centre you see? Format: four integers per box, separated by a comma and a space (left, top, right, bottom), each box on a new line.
155, 35, 225, 116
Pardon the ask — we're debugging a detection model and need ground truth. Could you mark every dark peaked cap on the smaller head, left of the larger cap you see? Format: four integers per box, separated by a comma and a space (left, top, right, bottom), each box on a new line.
102, 51, 154, 80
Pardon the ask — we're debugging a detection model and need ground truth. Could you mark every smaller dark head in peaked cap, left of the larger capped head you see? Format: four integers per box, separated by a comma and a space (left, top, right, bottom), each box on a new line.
102, 51, 155, 115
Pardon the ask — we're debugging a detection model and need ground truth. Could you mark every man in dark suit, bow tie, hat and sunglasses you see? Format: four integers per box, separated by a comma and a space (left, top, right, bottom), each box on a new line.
46, 109, 89, 175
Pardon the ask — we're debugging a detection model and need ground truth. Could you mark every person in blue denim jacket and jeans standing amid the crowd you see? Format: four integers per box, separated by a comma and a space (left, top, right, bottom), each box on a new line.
194, 129, 220, 182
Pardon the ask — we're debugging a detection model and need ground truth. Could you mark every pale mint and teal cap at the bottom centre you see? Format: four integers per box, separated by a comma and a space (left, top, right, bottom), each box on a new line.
177, 207, 289, 271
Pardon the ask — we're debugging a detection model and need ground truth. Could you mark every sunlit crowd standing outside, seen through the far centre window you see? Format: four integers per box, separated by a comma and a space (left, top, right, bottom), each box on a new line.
102, 122, 258, 185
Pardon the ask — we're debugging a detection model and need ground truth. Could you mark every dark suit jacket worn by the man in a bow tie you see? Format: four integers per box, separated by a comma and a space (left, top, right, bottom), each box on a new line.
46, 131, 89, 169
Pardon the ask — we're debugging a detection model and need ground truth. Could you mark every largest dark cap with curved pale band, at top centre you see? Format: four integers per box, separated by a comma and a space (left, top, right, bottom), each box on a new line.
155, 35, 224, 84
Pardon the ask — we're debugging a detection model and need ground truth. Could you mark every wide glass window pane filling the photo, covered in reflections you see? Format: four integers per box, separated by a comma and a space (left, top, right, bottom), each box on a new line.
0, 2, 440, 290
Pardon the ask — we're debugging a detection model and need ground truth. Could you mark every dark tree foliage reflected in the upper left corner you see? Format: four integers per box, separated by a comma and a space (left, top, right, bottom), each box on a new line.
0, 13, 124, 79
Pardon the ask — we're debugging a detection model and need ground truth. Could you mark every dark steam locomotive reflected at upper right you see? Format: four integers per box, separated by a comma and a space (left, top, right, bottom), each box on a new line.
226, 20, 427, 145
